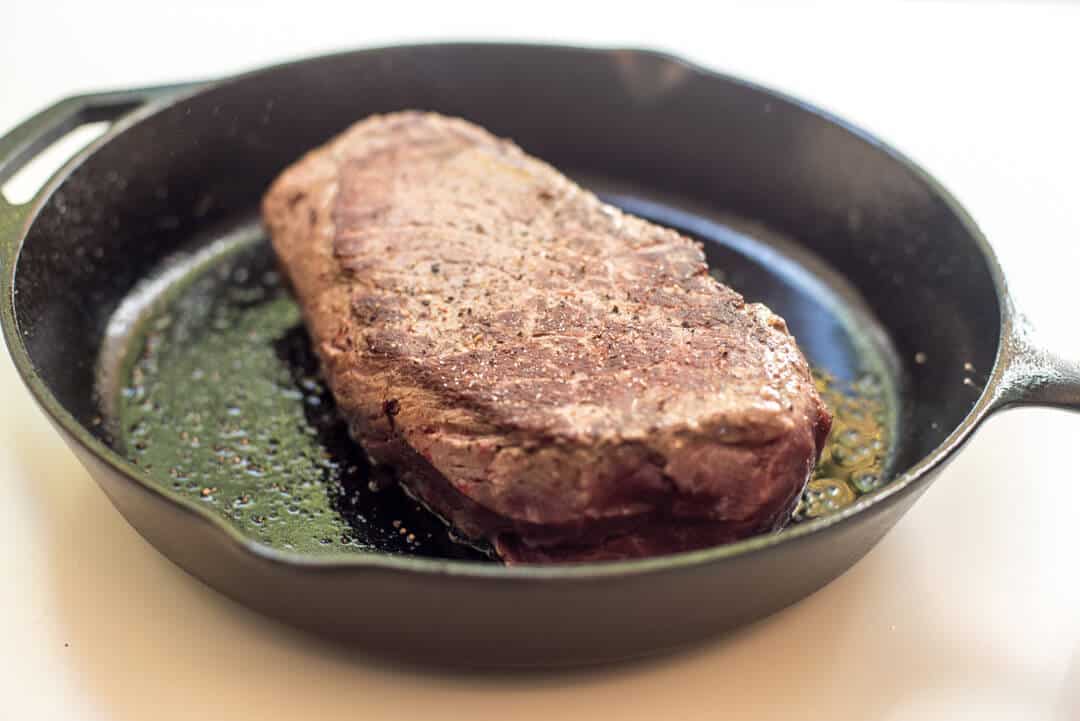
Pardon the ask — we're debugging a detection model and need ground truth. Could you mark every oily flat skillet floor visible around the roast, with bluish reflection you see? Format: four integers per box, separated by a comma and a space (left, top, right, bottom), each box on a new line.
78, 194, 897, 560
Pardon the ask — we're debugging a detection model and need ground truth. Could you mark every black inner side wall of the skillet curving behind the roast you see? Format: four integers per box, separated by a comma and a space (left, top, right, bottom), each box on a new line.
15, 45, 1000, 556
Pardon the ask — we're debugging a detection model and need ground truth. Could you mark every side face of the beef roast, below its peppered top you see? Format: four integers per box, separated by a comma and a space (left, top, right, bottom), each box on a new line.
264, 112, 831, 562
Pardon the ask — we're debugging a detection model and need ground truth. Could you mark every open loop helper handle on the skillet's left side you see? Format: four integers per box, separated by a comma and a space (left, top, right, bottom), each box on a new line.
0, 83, 203, 243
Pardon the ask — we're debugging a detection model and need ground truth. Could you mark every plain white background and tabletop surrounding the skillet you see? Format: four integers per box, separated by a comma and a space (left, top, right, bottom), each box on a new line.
0, 0, 1080, 721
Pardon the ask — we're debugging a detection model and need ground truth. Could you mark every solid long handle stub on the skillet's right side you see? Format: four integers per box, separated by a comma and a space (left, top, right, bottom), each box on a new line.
990, 312, 1080, 411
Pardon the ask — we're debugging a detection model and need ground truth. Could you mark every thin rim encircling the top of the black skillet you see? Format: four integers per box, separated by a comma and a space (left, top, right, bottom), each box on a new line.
0, 41, 1015, 582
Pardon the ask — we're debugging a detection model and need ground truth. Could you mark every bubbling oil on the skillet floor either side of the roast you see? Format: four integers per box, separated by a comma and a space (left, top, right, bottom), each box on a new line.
103, 216, 888, 560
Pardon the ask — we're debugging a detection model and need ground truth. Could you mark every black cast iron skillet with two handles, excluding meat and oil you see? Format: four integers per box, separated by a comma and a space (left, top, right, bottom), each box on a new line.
0, 44, 1080, 665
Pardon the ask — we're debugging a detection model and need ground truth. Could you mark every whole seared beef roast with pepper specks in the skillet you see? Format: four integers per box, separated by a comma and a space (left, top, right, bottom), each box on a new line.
264, 112, 831, 562
